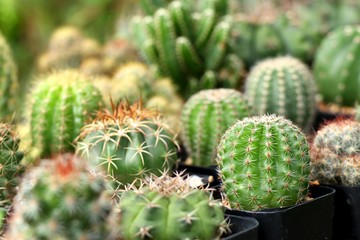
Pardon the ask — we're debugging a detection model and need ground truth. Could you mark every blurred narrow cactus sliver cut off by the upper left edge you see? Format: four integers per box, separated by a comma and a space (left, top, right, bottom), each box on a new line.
0, 32, 18, 121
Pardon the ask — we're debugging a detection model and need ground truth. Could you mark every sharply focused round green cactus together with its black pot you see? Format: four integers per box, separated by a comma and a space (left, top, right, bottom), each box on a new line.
217, 115, 335, 240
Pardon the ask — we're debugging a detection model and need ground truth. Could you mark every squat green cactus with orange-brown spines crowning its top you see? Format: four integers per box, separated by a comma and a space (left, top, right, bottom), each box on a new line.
77, 102, 177, 185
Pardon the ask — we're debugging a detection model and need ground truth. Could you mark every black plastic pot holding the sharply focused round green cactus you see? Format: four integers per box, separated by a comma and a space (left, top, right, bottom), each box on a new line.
226, 186, 335, 240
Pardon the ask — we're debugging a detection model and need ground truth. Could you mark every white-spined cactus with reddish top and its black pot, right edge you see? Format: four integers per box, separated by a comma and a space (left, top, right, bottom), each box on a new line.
310, 119, 360, 240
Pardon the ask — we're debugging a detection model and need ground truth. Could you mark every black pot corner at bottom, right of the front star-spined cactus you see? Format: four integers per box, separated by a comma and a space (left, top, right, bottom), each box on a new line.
221, 214, 259, 240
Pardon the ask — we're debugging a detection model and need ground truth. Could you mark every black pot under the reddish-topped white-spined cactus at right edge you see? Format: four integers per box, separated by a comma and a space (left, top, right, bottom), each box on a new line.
326, 185, 360, 240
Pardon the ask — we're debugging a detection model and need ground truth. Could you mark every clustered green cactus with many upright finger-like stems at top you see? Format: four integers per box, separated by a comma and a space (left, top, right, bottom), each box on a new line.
133, 0, 243, 96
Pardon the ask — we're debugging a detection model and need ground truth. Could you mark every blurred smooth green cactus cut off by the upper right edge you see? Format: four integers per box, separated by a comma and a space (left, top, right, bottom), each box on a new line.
314, 25, 360, 107
